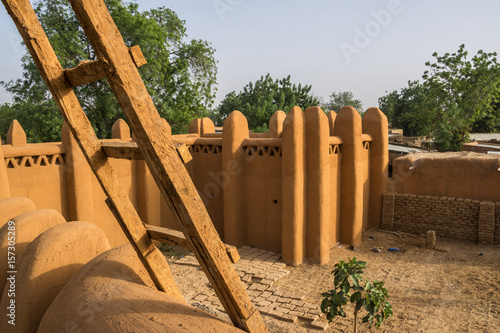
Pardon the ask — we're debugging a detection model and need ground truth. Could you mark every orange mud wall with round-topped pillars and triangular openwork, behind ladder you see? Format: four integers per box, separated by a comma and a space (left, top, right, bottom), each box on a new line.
0, 107, 388, 265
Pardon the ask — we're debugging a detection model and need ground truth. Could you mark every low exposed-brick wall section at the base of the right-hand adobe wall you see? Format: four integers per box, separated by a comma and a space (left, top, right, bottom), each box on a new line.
382, 193, 500, 244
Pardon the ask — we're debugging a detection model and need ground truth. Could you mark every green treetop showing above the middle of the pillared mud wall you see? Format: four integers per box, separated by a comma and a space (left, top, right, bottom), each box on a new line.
213, 74, 319, 132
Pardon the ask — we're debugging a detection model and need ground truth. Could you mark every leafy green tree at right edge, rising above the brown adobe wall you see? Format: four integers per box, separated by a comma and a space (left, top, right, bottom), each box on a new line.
423, 44, 500, 150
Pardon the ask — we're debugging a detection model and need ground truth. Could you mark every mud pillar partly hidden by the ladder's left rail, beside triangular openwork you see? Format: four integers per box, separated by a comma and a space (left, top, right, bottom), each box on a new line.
61, 122, 94, 222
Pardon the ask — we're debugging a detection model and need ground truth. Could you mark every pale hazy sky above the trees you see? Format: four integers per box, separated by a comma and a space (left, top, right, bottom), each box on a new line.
0, 0, 500, 109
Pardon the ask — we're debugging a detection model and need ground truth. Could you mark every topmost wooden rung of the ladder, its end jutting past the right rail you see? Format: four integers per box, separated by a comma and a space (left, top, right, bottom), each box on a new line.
64, 45, 147, 87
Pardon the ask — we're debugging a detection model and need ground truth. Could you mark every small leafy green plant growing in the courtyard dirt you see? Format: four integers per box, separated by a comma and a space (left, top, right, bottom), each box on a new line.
321, 257, 392, 332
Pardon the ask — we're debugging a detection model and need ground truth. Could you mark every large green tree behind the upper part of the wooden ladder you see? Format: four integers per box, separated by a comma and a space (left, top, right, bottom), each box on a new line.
0, 0, 217, 142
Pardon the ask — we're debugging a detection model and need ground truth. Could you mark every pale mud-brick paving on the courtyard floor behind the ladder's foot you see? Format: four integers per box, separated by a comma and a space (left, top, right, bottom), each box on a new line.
173, 246, 328, 330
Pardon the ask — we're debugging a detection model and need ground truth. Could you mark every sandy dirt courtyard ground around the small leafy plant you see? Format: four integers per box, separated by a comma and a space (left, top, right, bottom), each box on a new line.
170, 230, 500, 332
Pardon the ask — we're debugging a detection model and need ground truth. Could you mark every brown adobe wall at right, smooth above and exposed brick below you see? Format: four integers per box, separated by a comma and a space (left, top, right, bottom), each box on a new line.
381, 152, 500, 244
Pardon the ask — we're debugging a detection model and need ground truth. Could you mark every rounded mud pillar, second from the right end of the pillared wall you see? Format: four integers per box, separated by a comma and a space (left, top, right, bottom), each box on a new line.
334, 106, 363, 246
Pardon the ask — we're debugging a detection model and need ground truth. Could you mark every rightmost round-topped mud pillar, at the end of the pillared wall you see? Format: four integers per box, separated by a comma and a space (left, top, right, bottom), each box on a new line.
363, 108, 389, 228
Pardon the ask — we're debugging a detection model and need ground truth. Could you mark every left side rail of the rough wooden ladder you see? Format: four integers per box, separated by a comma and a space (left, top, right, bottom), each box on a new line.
2, 0, 184, 300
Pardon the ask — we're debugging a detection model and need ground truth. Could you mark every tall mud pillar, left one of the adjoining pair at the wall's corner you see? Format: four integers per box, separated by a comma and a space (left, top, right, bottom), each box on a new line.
281, 106, 306, 266
